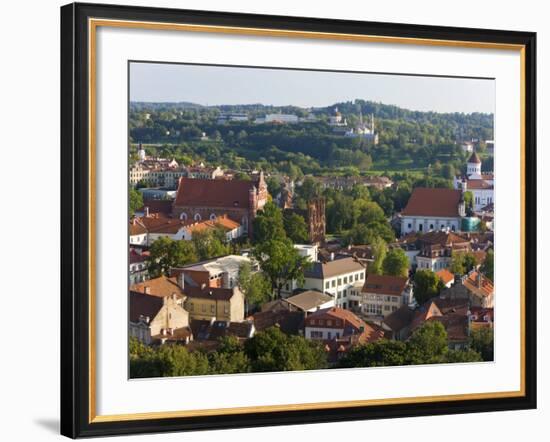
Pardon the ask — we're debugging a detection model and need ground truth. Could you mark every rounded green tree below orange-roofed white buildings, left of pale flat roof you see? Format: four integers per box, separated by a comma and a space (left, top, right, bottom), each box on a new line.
147, 237, 197, 278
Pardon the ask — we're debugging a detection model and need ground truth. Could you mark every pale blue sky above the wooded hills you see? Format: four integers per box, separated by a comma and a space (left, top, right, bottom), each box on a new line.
130, 62, 495, 113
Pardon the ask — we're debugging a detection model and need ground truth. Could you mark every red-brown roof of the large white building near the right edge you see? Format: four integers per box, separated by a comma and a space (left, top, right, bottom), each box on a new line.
401, 187, 462, 218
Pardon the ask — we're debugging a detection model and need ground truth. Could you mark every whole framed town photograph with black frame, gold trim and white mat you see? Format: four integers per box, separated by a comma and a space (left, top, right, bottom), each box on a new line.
61, 4, 536, 438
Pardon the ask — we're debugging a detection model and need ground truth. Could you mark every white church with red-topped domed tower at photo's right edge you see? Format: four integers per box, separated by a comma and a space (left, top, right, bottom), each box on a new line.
454, 152, 495, 212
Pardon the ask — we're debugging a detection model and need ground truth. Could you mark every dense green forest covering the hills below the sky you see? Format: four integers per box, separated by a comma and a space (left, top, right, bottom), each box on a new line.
129, 100, 493, 178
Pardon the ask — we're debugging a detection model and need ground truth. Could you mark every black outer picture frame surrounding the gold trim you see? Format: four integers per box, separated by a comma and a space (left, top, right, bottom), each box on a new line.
61, 3, 537, 438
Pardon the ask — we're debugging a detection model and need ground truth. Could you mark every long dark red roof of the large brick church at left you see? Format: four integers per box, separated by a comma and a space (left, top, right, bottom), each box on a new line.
174, 177, 257, 208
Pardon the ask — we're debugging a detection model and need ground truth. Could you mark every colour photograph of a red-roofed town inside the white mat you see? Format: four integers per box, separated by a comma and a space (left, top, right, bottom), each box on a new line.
128, 62, 495, 378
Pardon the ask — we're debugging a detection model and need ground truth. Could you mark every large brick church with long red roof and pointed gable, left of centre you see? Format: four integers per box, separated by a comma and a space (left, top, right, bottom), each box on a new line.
172, 172, 268, 236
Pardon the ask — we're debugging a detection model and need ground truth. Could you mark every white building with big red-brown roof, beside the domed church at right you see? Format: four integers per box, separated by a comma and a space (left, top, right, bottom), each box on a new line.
401, 187, 466, 235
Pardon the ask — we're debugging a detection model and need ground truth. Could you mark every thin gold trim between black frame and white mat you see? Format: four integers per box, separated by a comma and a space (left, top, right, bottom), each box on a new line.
88, 18, 526, 423
